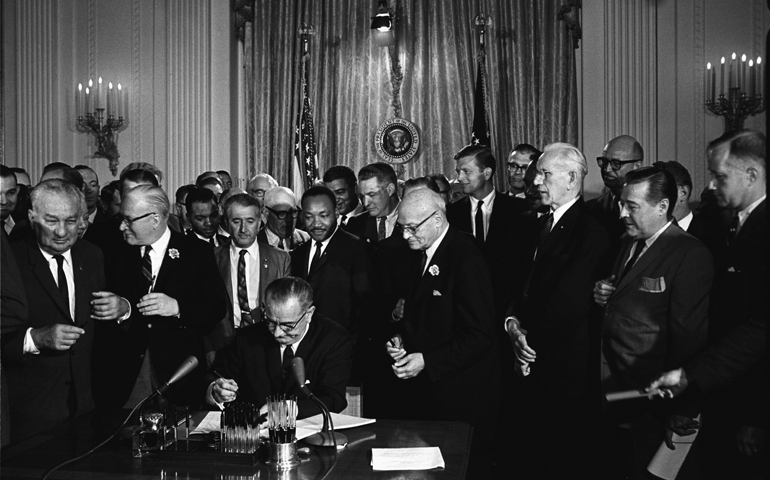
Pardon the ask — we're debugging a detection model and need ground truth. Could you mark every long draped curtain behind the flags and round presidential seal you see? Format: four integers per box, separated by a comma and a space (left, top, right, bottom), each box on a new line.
236, 0, 578, 187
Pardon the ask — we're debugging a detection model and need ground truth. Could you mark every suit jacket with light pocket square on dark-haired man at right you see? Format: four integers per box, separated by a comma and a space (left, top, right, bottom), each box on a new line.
602, 223, 714, 391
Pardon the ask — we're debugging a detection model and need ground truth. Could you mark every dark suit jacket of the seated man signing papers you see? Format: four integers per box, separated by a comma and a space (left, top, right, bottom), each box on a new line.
210, 313, 351, 418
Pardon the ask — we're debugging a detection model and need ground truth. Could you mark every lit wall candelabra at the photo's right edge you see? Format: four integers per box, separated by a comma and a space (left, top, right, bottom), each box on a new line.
706, 53, 765, 132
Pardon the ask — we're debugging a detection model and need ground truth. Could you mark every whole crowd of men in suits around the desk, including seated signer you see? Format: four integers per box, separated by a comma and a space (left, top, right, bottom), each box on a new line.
0, 130, 768, 479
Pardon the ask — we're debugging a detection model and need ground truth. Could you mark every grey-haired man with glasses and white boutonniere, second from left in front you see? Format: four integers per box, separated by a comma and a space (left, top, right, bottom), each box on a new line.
94, 185, 227, 409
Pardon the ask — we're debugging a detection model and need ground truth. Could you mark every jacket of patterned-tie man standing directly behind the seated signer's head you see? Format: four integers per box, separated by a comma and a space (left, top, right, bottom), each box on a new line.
204, 242, 291, 365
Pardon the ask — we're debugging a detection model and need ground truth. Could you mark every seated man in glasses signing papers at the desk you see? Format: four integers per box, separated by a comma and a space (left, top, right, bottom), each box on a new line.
206, 277, 351, 418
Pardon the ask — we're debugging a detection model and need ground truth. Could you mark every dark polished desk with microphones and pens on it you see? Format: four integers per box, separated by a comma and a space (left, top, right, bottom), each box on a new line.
0, 415, 471, 480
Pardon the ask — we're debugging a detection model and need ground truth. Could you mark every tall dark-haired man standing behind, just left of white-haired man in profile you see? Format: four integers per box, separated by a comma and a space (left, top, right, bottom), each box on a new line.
447, 145, 526, 320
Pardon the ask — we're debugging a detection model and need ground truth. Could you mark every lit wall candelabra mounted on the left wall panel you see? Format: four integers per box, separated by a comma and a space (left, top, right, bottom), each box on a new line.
75, 77, 128, 175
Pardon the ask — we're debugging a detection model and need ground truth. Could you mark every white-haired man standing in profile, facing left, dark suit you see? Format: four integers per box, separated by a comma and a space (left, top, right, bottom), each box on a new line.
505, 143, 610, 478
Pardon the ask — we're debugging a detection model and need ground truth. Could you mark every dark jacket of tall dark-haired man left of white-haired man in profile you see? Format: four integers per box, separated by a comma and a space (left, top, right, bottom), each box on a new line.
447, 192, 526, 318
